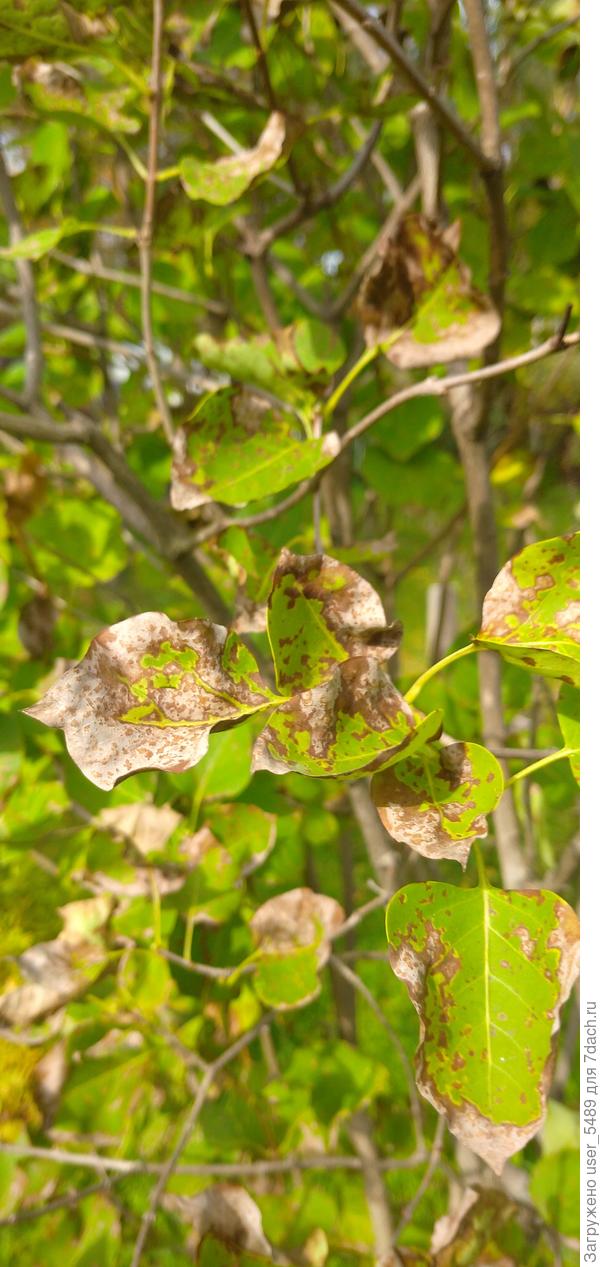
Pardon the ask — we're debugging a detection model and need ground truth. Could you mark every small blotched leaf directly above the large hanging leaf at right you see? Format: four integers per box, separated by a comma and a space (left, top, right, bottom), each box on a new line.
371, 744, 504, 868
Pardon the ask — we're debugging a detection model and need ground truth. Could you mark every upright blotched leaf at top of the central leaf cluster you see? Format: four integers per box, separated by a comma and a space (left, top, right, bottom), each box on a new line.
267, 550, 400, 694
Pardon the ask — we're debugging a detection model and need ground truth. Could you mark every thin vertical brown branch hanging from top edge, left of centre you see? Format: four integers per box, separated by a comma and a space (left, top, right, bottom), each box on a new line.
138, 0, 175, 443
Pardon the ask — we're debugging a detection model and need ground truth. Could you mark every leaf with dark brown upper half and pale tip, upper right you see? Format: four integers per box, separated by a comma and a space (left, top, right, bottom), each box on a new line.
357, 215, 500, 370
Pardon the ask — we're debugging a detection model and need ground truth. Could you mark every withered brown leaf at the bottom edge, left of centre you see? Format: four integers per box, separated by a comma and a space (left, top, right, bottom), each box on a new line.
162, 1183, 272, 1259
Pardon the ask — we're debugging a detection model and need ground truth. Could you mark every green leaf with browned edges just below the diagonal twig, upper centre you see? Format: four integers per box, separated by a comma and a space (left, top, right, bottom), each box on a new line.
171, 388, 339, 511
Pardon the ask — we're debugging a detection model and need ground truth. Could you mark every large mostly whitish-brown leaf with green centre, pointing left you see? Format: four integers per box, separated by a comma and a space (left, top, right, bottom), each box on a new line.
25, 612, 276, 789
